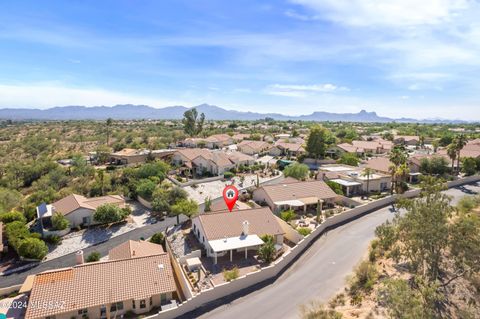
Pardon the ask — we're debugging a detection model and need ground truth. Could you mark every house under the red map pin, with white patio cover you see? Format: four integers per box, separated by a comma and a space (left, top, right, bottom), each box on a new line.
192, 207, 284, 263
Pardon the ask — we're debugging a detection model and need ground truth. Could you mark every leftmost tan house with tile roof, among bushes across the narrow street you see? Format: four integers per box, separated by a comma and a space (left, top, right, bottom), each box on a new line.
37, 194, 126, 227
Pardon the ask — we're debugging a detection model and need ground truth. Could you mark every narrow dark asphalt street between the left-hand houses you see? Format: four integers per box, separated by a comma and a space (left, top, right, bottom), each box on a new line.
0, 215, 186, 288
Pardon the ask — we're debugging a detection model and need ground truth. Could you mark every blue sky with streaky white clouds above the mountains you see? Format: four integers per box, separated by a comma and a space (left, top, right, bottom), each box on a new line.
0, 0, 480, 120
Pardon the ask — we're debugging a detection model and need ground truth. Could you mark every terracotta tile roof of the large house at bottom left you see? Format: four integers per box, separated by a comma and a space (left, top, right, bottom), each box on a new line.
25, 253, 176, 319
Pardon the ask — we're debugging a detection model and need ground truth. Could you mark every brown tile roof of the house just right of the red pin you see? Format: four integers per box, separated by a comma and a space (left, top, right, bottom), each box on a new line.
260, 181, 338, 202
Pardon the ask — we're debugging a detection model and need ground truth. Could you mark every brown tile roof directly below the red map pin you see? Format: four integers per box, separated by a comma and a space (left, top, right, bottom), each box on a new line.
195, 207, 284, 240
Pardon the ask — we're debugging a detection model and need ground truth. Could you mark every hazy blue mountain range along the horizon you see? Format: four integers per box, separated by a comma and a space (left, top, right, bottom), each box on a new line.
0, 104, 465, 123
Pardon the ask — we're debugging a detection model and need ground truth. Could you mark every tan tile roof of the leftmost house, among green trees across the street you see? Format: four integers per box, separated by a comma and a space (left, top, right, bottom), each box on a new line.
52, 194, 125, 215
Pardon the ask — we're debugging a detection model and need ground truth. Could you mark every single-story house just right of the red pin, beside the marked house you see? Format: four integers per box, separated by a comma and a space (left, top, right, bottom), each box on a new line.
253, 180, 338, 213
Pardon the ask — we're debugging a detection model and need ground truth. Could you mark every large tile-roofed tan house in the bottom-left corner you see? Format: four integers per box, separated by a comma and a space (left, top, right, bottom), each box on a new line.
21, 252, 179, 319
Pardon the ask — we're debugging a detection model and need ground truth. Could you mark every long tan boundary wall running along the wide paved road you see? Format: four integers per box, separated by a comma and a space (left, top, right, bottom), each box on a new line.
131, 175, 480, 319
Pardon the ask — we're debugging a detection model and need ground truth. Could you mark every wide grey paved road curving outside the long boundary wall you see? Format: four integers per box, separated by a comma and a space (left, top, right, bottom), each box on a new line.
192, 184, 480, 319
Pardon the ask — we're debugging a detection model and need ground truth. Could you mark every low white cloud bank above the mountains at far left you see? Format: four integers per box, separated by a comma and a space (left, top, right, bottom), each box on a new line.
0, 83, 187, 108
